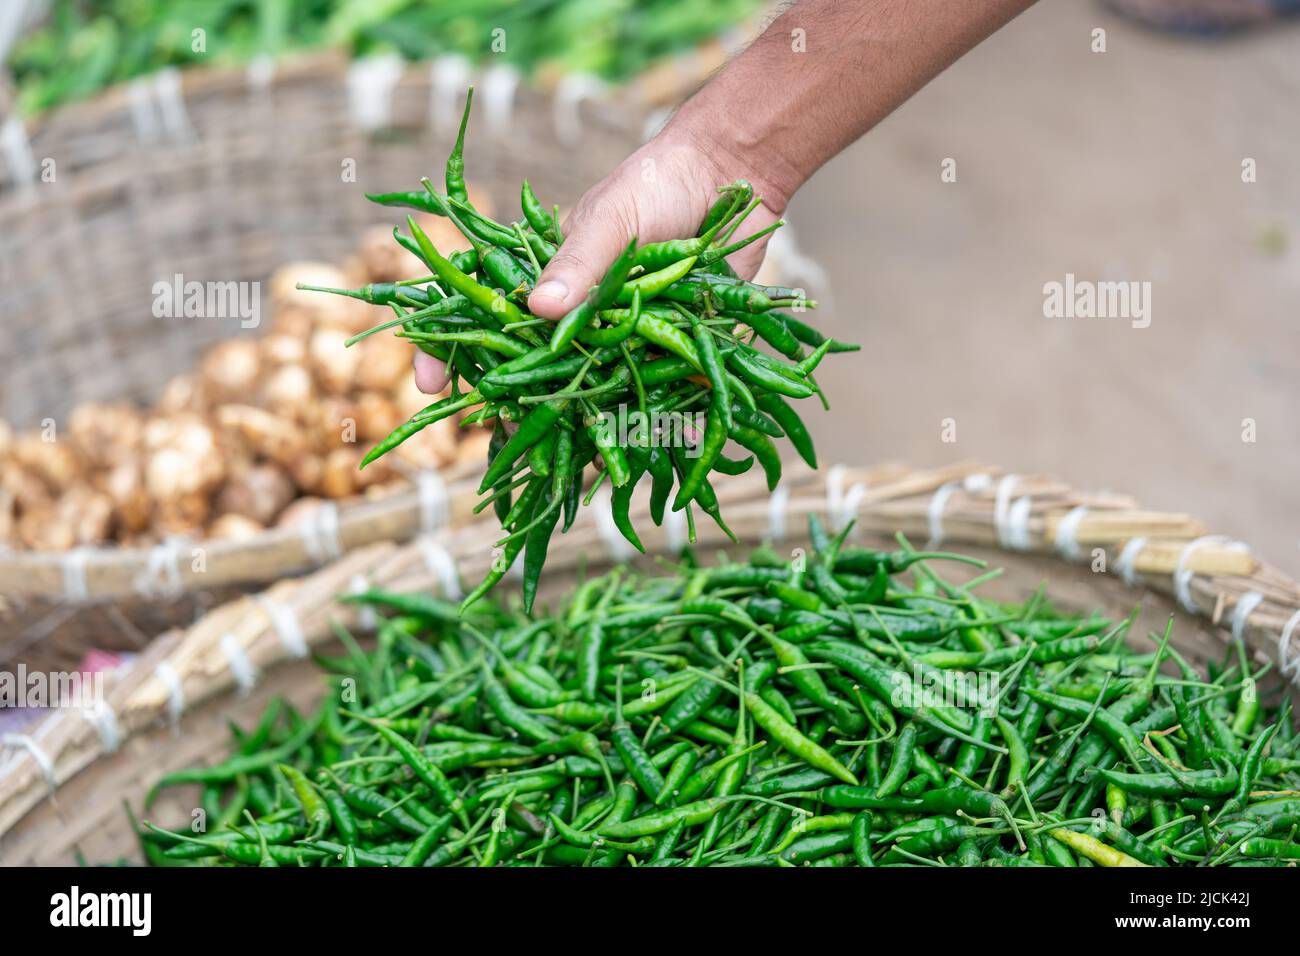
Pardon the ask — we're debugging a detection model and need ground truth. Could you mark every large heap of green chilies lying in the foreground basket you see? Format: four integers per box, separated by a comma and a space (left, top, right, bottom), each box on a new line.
139, 522, 1300, 866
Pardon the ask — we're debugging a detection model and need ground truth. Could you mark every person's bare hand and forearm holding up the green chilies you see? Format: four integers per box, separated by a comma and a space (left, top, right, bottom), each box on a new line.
416, 0, 1034, 392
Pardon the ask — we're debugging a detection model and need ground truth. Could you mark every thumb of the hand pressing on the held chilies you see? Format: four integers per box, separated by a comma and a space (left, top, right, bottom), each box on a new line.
528, 200, 632, 319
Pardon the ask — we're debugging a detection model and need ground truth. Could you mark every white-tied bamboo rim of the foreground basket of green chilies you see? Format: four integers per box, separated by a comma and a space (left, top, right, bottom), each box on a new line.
0, 463, 1300, 838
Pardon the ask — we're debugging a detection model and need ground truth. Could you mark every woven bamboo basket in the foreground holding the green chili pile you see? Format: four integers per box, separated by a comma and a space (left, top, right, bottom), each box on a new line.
0, 464, 1300, 865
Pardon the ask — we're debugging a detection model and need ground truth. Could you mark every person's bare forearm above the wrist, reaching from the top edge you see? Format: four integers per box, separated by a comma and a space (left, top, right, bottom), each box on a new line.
670, 0, 1034, 209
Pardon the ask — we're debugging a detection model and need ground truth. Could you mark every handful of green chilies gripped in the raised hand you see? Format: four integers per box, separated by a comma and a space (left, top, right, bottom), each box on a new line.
299, 90, 857, 610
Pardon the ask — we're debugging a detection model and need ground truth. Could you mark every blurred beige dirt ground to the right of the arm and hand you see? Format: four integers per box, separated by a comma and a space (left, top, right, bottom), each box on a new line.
790, 0, 1300, 572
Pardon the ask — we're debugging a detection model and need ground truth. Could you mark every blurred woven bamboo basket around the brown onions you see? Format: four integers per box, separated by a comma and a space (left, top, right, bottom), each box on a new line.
0, 47, 696, 669
